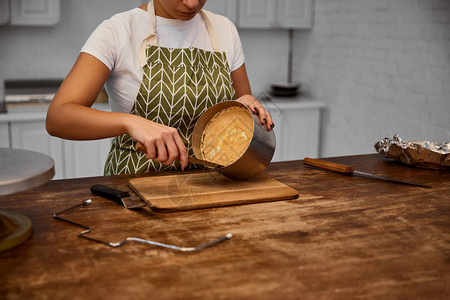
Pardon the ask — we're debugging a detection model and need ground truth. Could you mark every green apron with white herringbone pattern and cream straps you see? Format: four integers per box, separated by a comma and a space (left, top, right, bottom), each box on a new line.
104, 1, 235, 175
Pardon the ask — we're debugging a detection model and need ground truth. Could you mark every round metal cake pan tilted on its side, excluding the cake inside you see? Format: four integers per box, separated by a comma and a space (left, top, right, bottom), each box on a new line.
192, 100, 276, 180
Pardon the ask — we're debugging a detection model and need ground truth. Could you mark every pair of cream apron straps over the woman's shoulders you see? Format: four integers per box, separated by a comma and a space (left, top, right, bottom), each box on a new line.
139, 0, 221, 68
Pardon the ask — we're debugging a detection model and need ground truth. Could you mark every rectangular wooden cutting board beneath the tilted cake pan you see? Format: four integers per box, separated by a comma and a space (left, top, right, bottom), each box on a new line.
129, 172, 298, 212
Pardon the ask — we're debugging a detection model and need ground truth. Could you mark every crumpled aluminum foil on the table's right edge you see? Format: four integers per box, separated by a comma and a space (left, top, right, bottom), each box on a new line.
374, 135, 450, 170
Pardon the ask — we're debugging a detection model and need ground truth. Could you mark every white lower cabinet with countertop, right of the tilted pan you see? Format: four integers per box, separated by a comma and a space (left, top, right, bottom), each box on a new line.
262, 97, 324, 161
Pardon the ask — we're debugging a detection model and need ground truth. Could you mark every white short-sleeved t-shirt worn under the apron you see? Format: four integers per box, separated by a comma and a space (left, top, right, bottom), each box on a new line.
81, 8, 244, 113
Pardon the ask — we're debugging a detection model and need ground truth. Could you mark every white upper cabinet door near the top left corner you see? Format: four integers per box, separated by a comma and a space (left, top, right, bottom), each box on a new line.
10, 0, 60, 26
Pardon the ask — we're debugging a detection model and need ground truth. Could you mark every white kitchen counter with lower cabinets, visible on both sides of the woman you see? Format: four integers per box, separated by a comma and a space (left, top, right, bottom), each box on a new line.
0, 99, 325, 166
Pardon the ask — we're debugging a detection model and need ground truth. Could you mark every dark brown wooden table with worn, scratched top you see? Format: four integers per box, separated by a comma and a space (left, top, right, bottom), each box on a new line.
0, 154, 450, 299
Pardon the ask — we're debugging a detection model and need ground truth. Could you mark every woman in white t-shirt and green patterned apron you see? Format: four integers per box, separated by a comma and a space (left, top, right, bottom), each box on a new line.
46, 0, 274, 175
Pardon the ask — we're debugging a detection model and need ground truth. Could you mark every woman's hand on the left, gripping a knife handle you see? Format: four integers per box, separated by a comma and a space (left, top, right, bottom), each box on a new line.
126, 115, 188, 170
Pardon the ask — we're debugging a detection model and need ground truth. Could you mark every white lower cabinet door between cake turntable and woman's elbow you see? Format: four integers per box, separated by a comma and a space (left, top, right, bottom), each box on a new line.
9, 119, 64, 179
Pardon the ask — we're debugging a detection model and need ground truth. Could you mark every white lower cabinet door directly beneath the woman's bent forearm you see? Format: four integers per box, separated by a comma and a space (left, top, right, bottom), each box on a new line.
64, 139, 111, 178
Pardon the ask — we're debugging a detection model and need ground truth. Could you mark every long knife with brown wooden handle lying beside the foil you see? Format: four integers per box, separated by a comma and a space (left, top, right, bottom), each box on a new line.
303, 157, 431, 188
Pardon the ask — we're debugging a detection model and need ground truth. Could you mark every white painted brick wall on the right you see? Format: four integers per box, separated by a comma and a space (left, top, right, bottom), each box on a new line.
294, 0, 450, 156
